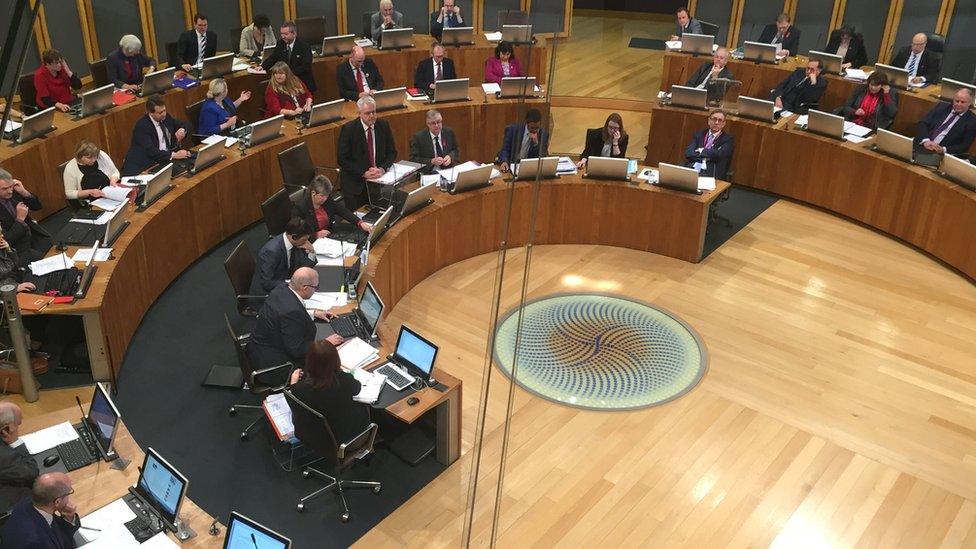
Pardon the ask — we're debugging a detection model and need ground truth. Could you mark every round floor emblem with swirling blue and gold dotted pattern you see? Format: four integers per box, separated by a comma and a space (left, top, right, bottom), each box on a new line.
494, 294, 708, 410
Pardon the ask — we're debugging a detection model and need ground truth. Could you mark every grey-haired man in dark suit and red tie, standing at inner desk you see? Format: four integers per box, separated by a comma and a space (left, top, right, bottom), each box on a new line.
336, 95, 397, 211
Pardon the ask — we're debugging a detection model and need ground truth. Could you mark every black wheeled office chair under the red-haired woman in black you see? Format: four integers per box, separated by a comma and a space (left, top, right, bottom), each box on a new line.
283, 389, 383, 522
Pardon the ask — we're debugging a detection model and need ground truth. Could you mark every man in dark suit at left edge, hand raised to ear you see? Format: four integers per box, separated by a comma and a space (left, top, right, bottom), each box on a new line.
0, 168, 51, 267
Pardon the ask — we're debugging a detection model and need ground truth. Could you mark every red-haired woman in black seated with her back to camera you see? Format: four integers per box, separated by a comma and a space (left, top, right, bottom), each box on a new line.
288, 336, 370, 444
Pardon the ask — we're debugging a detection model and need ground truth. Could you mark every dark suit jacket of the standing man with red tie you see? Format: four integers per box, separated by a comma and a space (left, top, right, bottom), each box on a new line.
337, 117, 397, 195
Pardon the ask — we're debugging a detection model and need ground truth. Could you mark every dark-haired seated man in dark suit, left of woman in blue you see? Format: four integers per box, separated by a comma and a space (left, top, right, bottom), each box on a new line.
122, 94, 190, 176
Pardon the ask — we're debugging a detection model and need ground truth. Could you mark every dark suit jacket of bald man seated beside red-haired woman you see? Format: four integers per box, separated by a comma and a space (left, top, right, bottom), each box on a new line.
245, 284, 315, 370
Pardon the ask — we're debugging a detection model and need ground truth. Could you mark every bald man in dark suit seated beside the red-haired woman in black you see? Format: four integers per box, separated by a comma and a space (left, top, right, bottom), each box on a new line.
245, 267, 342, 384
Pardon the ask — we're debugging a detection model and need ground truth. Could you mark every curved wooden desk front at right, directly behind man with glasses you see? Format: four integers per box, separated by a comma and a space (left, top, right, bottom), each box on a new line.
645, 103, 976, 280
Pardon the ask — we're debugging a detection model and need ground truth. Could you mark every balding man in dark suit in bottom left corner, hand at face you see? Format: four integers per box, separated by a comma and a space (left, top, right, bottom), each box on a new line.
0, 473, 81, 549
